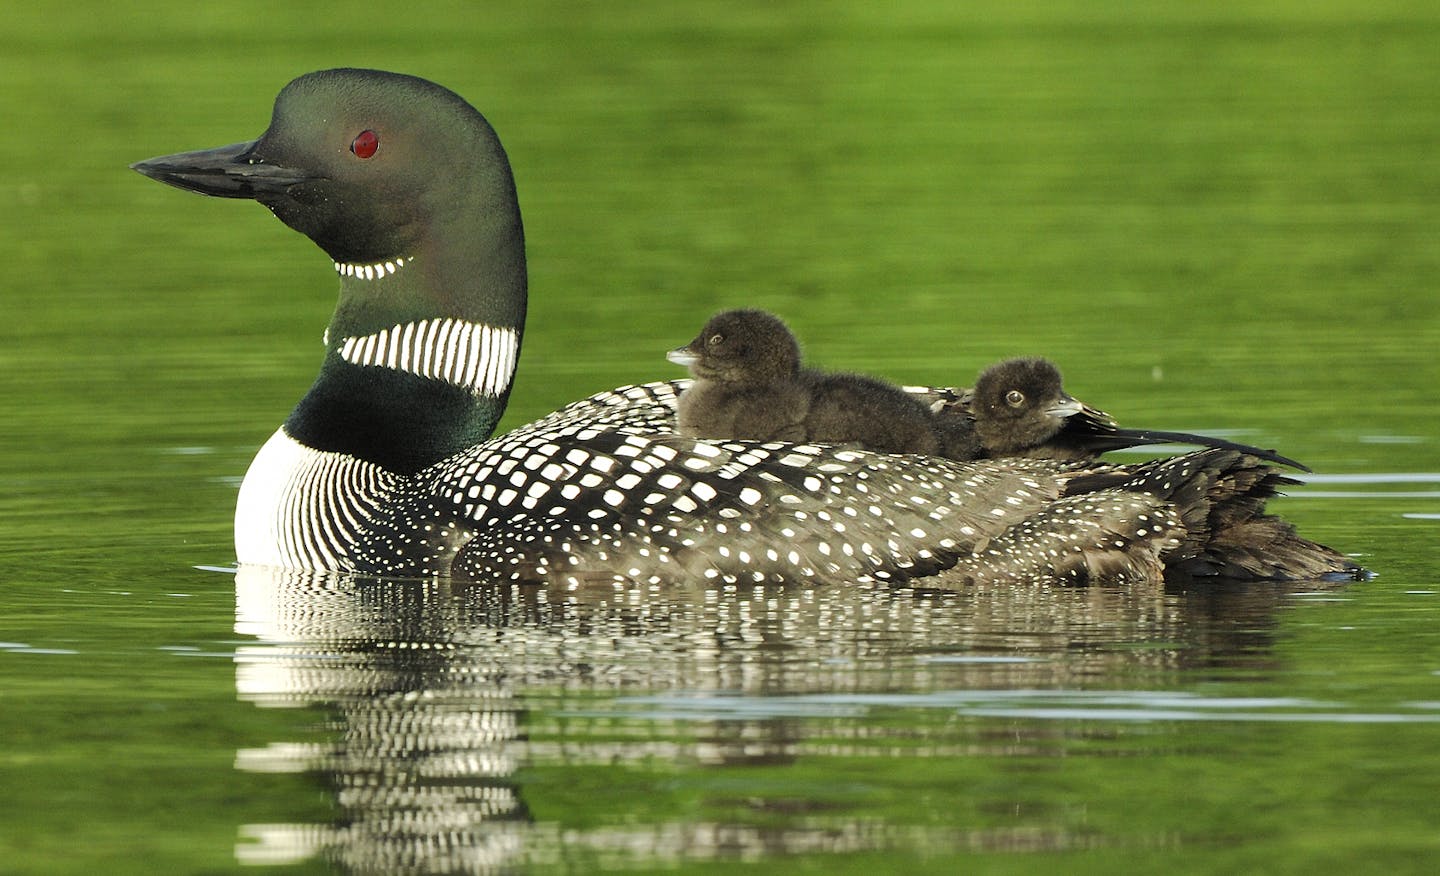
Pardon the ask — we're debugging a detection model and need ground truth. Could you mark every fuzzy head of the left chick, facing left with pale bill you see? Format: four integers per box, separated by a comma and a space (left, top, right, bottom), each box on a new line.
667, 310, 801, 385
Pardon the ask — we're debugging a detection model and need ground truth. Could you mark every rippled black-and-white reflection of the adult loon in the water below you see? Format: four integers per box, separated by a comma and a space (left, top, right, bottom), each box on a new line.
236, 568, 1301, 873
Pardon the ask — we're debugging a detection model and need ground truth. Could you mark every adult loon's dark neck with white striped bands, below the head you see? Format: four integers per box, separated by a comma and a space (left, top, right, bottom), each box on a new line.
285, 215, 526, 474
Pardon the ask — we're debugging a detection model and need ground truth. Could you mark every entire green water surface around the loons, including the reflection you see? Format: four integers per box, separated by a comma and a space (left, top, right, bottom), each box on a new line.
0, 0, 1440, 873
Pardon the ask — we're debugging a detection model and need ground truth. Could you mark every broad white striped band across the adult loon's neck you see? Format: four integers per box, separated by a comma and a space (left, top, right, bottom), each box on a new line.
338, 318, 520, 396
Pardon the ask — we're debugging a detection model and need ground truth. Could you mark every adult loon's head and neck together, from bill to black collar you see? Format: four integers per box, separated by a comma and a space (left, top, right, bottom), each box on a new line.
132, 69, 527, 470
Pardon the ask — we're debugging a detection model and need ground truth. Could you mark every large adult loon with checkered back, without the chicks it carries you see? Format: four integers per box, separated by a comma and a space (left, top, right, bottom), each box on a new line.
132, 69, 1358, 588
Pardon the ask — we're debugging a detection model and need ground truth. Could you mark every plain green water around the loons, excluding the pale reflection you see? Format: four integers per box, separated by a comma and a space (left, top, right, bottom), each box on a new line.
0, 0, 1440, 873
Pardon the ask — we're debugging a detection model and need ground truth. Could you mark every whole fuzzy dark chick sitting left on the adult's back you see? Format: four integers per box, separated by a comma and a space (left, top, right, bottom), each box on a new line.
667, 310, 939, 454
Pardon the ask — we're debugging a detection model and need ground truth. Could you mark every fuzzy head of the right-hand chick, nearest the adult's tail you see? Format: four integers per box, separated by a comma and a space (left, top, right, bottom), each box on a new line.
971, 359, 1084, 455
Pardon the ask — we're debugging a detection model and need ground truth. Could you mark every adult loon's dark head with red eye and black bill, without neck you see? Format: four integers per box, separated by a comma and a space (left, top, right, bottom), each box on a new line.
132, 69, 520, 285
